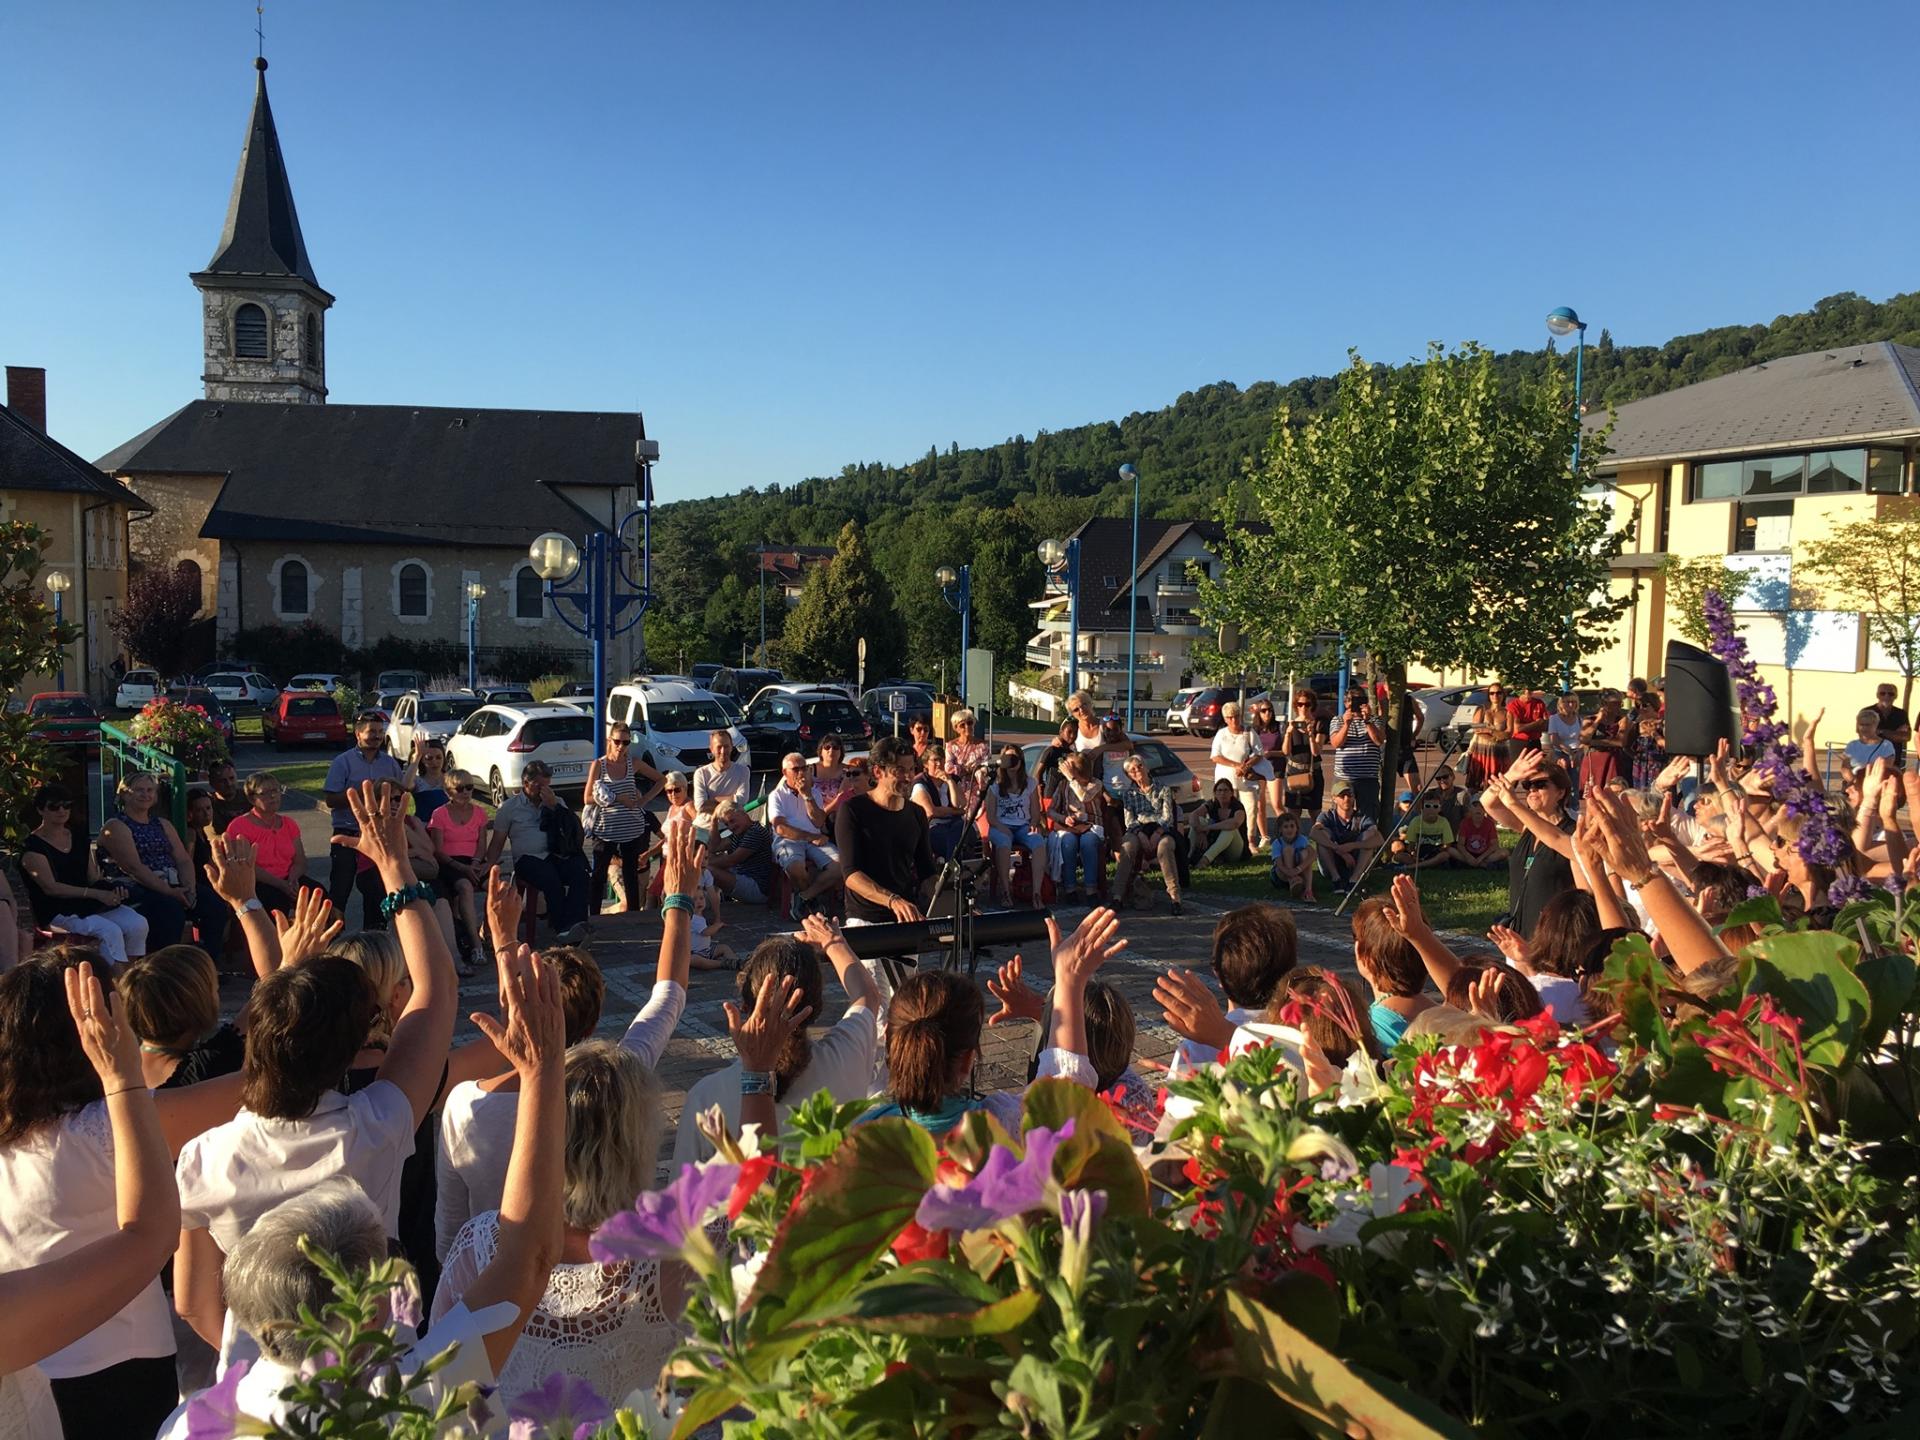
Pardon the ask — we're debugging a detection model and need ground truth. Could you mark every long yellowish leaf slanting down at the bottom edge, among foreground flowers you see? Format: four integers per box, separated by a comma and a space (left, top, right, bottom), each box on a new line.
1227, 1290, 1471, 1440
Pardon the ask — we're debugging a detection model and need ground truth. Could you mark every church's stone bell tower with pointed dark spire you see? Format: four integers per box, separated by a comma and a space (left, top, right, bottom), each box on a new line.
192, 56, 334, 405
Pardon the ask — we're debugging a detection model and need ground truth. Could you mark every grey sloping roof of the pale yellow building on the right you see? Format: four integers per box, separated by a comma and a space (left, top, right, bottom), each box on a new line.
1588, 340, 1920, 470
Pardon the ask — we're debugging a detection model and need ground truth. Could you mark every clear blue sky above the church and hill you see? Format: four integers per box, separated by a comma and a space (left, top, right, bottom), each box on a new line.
0, 0, 1920, 499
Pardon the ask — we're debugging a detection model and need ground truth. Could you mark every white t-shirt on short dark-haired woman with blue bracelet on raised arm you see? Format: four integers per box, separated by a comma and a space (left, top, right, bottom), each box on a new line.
175, 1081, 413, 1254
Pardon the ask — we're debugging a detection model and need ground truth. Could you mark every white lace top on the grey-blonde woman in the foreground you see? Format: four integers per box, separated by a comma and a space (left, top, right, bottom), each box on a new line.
426, 1210, 685, 1400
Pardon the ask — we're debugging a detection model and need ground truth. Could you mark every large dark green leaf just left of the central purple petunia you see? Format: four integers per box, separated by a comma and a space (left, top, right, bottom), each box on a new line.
747, 1119, 933, 1336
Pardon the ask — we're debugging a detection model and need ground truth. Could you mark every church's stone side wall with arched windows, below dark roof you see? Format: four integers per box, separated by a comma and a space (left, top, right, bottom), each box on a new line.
221, 541, 634, 674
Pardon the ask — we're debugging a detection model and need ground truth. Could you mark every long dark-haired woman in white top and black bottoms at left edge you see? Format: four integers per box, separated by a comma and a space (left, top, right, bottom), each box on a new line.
0, 947, 240, 1436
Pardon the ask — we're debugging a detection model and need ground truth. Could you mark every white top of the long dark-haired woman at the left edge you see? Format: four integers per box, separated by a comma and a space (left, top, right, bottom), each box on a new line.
0, 1100, 173, 1380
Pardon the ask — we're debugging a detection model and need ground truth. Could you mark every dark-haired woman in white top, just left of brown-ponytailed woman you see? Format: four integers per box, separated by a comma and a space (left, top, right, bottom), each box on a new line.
668, 916, 881, 1175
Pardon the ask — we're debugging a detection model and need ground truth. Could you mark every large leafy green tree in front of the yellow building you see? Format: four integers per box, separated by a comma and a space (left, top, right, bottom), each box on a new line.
1200, 344, 1626, 822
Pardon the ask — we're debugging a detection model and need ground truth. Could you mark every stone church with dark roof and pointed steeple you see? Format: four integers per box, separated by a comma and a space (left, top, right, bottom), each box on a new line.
96, 58, 659, 678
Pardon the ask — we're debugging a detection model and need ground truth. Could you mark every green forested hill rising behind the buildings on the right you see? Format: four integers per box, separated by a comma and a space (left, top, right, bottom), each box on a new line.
649, 292, 1920, 683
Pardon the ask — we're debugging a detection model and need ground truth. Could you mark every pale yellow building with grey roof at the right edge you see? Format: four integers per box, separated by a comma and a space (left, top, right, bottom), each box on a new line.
1588, 342, 1920, 743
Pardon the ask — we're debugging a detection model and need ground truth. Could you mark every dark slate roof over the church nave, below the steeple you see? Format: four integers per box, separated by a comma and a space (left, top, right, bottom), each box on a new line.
98, 399, 647, 547
